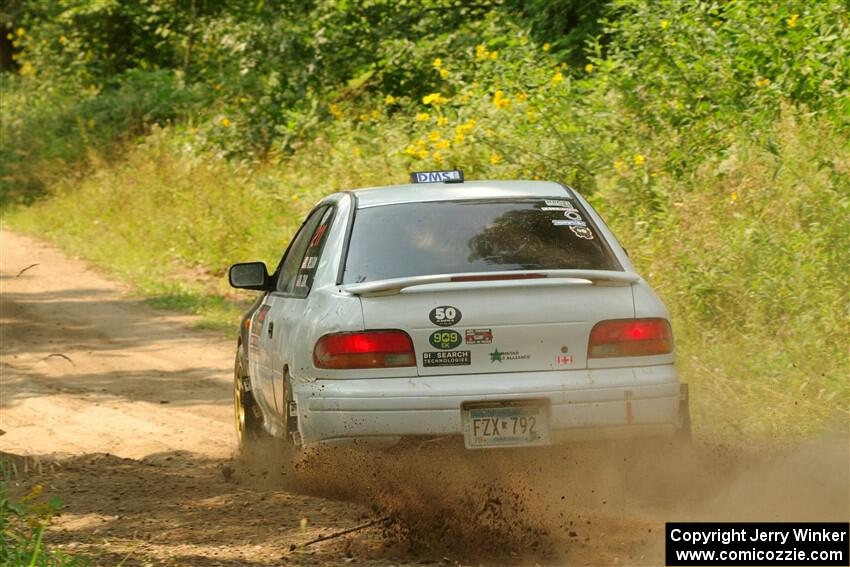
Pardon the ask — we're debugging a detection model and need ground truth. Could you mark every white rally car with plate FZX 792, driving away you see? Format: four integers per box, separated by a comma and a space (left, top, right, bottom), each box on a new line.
229, 171, 690, 449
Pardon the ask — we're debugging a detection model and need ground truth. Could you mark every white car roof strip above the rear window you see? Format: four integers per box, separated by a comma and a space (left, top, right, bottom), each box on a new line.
352, 181, 571, 209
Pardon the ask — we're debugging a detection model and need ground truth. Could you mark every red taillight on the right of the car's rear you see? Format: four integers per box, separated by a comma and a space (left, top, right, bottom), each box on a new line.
587, 319, 673, 358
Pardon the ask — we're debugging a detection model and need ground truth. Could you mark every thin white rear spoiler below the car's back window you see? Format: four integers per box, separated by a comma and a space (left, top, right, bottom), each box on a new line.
342, 270, 640, 295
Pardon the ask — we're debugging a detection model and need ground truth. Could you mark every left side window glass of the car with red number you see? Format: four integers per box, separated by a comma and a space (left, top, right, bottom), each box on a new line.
277, 207, 333, 297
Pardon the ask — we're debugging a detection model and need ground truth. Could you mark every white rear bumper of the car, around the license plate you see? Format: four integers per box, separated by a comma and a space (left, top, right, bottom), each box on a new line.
293, 365, 683, 445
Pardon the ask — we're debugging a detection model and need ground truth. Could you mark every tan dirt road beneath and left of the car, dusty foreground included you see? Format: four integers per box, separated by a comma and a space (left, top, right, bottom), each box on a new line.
0, 230, 850, 565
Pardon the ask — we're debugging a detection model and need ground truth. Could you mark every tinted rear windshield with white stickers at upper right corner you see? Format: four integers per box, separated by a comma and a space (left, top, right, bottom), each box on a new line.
343, 197, 622, 283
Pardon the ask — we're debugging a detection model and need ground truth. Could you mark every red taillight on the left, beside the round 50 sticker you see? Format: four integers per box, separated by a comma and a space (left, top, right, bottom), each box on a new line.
313, 331, 416, 370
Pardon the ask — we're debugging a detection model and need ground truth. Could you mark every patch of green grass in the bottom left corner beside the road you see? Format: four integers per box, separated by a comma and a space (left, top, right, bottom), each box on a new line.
0, 460, 87, 567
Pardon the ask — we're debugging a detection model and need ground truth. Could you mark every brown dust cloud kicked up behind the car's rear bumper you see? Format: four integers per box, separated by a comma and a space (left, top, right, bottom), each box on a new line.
236, 434, 850, 565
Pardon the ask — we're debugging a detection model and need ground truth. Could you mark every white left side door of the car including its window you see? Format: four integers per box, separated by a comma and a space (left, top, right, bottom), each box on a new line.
261, 205, 333, 422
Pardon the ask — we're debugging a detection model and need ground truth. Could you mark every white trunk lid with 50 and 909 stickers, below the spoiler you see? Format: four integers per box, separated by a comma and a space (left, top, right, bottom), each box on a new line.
354, 279, 634, 376
